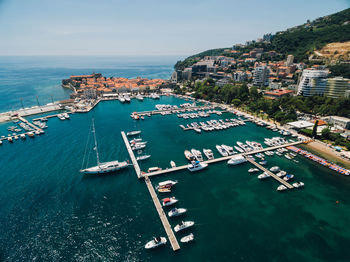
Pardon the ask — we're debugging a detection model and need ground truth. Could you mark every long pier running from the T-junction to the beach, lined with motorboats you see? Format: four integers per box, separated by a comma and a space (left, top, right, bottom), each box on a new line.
141, 141, 304, 177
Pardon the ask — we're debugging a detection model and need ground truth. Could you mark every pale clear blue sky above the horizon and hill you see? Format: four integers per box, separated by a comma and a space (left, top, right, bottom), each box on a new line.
0, 0, 350, 55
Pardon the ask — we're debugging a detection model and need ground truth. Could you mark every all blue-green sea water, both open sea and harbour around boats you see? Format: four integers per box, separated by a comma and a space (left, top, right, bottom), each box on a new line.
0, 57, 350, 262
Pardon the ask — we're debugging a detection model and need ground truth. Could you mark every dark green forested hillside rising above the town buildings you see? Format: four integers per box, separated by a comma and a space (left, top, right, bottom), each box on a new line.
175, 8, 350, 70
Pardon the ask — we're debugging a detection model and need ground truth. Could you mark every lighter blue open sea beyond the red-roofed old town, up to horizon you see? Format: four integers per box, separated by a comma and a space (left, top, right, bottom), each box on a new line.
0, 56, 178, 112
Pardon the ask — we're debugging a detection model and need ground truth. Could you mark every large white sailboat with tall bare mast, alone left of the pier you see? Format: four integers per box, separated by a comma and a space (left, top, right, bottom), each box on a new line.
80, 121, 129, 174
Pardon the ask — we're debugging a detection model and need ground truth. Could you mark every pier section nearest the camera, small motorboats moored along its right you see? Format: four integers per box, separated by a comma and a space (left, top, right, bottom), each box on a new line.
145, 176, 180, 251
